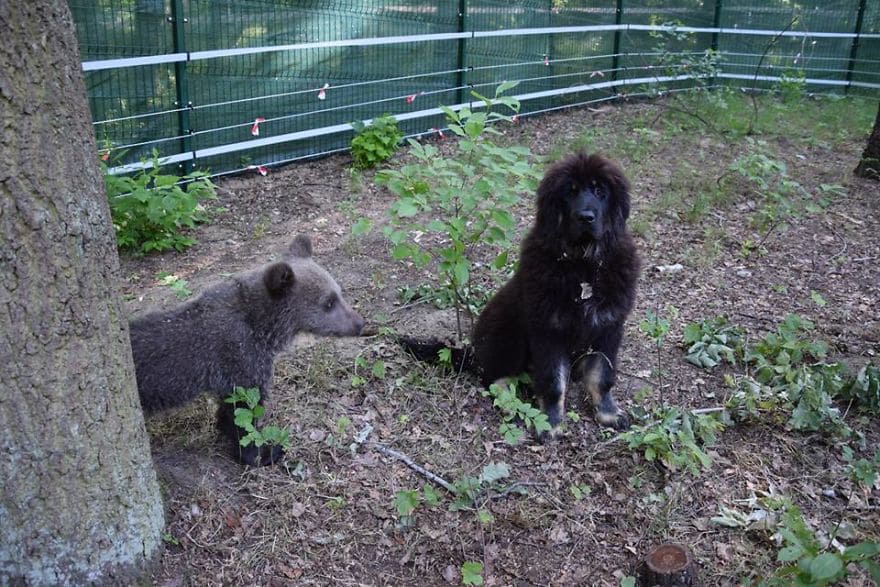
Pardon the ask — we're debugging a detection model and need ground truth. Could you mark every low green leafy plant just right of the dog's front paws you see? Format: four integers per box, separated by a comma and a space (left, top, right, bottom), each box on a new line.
620, 406, 724, 476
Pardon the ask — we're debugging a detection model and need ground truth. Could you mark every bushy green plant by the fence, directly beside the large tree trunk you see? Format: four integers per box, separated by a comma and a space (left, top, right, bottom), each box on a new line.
102, 151, 217, 254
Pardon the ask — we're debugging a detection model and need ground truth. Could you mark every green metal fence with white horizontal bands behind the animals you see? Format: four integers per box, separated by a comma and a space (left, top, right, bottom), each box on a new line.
70, 0, 880, 179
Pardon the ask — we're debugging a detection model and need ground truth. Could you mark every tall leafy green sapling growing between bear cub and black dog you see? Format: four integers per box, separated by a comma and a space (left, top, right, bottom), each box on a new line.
362, 83, 539, 339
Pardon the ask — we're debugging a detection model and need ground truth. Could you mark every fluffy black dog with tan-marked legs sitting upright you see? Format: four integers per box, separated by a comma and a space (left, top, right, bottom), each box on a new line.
401, 153, 640, 434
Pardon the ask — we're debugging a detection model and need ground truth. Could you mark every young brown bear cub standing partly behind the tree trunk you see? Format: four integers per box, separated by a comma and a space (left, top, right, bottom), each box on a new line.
130, 236, 364, 466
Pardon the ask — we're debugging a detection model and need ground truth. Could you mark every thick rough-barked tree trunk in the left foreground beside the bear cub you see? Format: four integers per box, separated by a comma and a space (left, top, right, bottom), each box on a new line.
0, 0, 164, 585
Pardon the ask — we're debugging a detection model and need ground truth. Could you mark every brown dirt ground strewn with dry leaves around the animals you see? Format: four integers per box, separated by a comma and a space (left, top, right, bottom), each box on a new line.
122, 97, 880, 587
